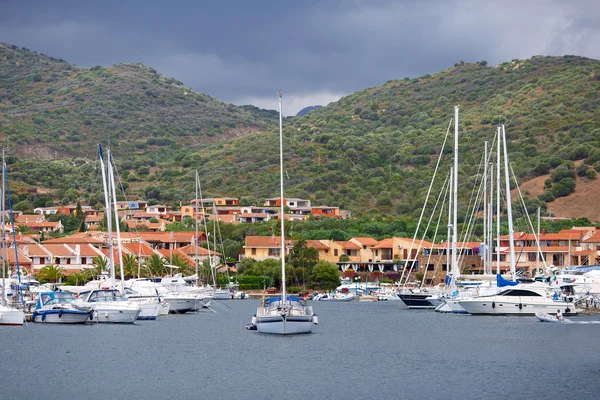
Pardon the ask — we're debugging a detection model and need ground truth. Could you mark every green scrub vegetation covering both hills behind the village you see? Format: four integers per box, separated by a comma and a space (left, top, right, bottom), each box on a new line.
0, 46, 600, 222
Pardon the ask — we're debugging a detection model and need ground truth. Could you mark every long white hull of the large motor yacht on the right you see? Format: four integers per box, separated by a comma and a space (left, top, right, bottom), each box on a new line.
458, 296, 577, 315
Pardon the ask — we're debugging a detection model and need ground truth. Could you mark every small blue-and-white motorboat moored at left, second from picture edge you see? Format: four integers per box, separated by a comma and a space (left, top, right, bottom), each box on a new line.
31, 292, 93, 324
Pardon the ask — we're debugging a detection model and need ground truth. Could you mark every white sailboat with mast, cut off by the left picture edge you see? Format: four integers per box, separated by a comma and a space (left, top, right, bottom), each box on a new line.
0, 149, 25, 325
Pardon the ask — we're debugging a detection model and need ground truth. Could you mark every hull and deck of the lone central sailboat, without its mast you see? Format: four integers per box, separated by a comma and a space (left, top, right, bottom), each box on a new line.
248, 296, 319, 335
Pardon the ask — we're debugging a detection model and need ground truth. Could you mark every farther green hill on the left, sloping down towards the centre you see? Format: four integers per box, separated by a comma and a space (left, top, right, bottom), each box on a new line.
0, 43, 277, 158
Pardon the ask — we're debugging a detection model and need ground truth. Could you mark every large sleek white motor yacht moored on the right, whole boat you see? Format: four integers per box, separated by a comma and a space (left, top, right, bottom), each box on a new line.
458, 285, 578, 315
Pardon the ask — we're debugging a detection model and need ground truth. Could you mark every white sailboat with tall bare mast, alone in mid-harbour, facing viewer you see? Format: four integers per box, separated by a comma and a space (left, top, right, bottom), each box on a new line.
249, 92, 318, 335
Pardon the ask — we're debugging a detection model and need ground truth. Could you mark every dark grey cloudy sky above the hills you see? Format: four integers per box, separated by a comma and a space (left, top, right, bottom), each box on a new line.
0, 0, 600, 115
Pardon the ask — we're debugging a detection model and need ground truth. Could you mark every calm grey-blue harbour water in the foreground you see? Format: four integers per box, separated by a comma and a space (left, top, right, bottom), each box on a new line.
0, 300, 600, 400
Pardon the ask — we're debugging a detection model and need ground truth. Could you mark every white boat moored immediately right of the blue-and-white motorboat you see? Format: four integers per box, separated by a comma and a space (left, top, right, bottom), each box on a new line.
79, 289, 141, 324
